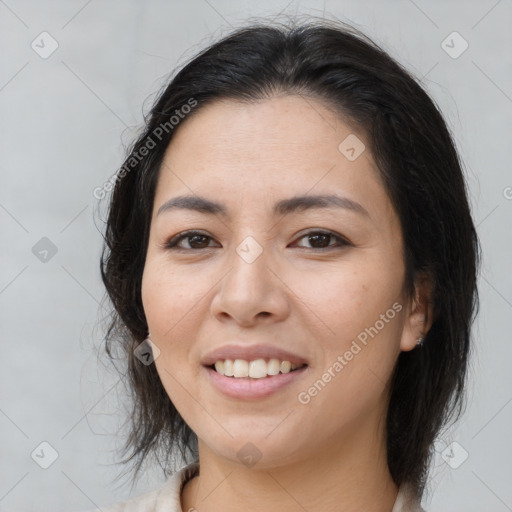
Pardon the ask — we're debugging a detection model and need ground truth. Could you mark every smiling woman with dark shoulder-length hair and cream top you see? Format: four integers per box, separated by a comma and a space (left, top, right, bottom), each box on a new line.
95, 17, 478, 512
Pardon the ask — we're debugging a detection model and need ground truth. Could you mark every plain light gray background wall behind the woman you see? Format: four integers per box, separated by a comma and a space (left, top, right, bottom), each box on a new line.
0, 0, 512, 512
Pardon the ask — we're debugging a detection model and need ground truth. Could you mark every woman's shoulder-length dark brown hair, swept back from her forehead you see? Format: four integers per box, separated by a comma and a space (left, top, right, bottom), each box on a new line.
101, 17, 479, 497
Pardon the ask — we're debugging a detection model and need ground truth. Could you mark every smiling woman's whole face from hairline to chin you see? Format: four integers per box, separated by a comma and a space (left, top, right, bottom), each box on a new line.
142, 96, 417, 467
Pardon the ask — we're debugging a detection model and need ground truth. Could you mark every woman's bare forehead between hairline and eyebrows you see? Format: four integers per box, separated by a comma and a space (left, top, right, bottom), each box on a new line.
155, 96, 389, 222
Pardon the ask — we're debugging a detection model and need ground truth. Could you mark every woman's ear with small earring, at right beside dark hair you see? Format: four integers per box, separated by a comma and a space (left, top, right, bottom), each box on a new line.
400, 274, 434, 352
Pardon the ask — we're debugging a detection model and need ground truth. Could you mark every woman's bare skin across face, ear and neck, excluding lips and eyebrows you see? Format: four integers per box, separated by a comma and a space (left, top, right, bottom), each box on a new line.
142, 95, 431, 512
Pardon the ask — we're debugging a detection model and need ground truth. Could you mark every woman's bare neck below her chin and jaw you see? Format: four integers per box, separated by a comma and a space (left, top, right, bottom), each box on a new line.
182, 418, 398, 512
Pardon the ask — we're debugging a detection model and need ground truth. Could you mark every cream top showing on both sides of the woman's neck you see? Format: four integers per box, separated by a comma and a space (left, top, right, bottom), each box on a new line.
88, 462, 425, 512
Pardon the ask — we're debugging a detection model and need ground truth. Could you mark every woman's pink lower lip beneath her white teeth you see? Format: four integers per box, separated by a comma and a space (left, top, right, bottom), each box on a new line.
204, 366, 307, 400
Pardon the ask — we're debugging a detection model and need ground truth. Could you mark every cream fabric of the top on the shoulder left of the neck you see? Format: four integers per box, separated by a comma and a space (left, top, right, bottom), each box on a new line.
80, 462, 199, 512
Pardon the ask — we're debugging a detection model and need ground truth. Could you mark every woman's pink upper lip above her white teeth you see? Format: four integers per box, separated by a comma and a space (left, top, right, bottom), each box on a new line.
201, 345, 307, 366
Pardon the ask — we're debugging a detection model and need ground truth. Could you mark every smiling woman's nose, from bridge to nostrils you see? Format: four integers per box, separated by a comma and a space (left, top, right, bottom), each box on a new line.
211, 237, 290, 327
